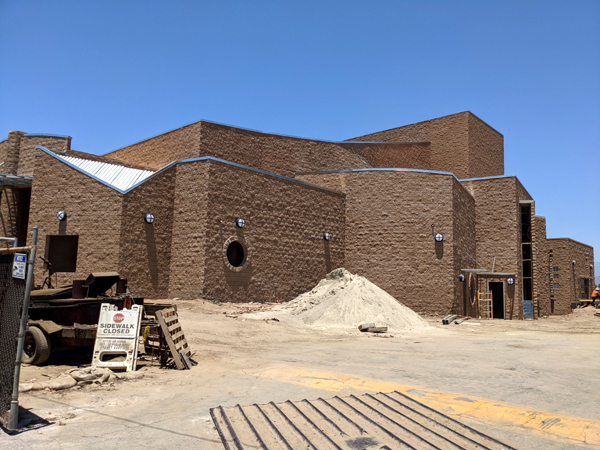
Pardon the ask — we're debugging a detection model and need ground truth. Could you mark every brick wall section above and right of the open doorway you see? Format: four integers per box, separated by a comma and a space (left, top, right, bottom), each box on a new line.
462, 177, 523, 319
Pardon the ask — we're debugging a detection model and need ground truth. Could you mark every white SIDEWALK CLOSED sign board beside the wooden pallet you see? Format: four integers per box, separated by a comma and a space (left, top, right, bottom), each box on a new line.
92, 303, 142, 372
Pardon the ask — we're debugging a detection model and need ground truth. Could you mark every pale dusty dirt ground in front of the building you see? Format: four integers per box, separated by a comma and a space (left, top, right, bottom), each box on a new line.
0, 300, 600, 450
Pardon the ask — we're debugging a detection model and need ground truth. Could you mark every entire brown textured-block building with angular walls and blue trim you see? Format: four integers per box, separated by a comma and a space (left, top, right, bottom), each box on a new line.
0, 112, 594, 319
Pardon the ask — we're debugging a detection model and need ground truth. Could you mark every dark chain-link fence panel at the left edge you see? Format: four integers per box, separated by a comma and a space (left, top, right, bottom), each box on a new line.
0, 253, 25, 423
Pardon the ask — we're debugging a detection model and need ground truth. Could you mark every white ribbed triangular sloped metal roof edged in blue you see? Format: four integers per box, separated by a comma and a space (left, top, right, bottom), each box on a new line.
56, 155, 154, 191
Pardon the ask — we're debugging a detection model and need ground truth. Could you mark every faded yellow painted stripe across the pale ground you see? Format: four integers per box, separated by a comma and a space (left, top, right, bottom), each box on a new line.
253, 366, 600, 448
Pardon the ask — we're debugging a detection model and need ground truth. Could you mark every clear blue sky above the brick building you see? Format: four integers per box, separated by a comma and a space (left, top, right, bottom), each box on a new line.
0, 0, 600, 258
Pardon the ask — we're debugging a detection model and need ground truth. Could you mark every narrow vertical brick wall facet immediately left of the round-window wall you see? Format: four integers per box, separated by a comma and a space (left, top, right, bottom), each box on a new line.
169, 162, 209, 299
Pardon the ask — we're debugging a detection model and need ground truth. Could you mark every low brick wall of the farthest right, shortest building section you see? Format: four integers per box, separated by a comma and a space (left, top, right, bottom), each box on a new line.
547, 238, 594, 314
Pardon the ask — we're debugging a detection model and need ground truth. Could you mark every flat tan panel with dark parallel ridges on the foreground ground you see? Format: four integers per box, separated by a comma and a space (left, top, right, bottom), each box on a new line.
210, 392, 514, 450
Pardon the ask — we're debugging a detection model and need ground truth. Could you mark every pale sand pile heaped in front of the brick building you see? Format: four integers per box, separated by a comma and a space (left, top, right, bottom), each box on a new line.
244, 268, 432, 331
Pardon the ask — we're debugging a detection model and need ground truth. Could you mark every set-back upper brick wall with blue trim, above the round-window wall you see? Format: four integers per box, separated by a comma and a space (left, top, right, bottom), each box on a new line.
200, 122, 369, 177
